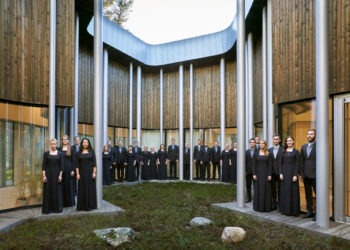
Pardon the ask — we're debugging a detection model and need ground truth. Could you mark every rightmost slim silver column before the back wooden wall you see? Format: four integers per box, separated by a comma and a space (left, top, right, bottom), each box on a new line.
220, 58, 226, 181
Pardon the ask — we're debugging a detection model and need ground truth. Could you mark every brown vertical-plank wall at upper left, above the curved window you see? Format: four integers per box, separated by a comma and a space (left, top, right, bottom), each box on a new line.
0, 0, 75, 106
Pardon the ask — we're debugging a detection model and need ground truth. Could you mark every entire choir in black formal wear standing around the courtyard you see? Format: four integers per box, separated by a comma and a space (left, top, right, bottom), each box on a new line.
42, 129, 316, 221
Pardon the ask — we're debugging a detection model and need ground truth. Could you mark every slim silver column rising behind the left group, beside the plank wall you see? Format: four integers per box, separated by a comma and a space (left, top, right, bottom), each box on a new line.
72, 12, 79, 140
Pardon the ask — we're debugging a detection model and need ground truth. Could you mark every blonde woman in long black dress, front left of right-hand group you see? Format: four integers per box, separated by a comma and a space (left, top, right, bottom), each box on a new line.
253, 140, 272, 212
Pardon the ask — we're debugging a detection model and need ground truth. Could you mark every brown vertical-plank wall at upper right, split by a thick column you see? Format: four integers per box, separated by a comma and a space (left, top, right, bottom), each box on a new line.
272, 0, 350, 103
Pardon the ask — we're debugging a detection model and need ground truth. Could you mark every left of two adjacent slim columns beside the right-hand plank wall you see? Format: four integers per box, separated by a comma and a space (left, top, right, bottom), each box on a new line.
262, 7, 268, 140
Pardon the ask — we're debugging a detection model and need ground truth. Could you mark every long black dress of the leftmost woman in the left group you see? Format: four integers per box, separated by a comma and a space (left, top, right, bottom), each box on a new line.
42, 151, 63, 214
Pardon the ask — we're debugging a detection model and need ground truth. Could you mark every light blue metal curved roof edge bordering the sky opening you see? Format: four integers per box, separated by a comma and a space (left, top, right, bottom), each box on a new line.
87, 0, 254, 66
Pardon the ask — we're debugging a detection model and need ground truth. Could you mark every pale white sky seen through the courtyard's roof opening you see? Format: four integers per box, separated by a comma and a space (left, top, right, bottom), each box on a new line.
125, 0, 236, 44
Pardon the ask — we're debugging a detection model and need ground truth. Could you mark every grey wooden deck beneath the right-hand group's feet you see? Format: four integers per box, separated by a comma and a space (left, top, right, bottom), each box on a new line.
212, 202, 350, 240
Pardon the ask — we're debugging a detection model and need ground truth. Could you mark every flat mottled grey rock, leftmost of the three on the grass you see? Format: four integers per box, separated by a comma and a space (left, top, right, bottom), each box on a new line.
94, 227, 136, 247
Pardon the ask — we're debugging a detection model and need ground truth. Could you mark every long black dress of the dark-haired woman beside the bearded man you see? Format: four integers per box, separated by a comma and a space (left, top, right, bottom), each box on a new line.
280, 148, 300, 216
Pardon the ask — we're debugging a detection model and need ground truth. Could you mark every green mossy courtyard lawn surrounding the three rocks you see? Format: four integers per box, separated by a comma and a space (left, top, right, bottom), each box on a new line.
0, 183, 350, 249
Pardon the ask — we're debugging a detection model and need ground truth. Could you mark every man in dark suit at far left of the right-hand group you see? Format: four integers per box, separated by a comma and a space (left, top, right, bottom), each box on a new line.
245, 138, 258, 202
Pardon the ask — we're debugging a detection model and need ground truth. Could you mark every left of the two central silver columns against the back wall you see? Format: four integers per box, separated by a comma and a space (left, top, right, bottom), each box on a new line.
179, 65, 184, 181
